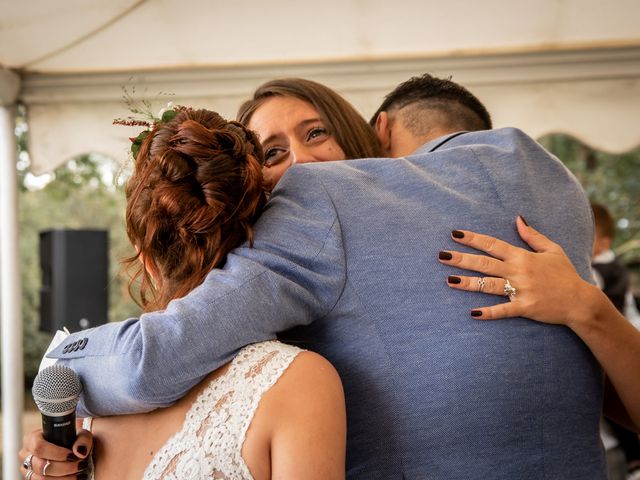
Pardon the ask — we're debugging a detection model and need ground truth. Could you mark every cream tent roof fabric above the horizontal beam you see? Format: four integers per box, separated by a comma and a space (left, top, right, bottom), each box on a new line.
0, 0, 640, 73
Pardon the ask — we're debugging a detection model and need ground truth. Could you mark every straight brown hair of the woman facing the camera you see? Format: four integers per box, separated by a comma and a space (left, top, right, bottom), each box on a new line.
236, 78, 382, 159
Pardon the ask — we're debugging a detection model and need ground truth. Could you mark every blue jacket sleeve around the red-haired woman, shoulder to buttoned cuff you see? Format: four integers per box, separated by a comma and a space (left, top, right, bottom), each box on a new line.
48, 165, 345, 416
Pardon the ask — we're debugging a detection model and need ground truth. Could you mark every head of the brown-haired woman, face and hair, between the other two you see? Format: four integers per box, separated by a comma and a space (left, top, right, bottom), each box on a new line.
237, 78, 382, 188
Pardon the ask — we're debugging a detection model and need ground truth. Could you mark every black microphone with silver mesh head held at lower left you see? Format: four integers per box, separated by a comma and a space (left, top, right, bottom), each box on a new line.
31, 363, 82, 449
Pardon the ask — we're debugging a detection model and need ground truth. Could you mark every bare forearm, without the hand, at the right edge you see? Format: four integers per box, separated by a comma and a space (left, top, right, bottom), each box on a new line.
569, 284, 640, 432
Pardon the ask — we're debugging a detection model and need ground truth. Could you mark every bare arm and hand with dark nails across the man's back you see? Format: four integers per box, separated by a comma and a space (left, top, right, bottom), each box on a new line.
440, 217, 640, 431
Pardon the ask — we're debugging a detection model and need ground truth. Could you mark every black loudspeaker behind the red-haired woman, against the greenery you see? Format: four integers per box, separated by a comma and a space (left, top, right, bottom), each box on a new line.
40, 230, 109, 333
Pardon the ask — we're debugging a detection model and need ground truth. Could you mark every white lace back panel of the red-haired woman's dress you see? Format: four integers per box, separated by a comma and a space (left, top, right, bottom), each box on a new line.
144, 341, 301, 480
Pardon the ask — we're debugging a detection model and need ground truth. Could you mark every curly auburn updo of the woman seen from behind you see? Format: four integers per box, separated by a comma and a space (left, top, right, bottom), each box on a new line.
124, 107, 266, 311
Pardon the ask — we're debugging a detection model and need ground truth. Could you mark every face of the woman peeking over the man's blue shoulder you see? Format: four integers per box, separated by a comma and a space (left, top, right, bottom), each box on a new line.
247, 96, 345, 189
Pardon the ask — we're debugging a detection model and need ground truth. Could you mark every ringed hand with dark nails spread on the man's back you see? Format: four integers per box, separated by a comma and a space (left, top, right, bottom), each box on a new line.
440, 217, 604, 326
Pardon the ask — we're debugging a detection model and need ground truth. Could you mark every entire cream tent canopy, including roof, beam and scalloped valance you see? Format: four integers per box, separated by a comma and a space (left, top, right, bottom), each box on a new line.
0, 0, 640, 173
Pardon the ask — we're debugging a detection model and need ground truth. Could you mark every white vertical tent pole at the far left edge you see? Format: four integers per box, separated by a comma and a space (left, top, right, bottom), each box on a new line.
0, 70, 24, 480
